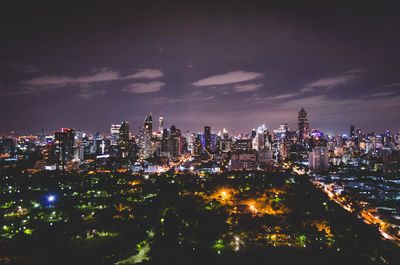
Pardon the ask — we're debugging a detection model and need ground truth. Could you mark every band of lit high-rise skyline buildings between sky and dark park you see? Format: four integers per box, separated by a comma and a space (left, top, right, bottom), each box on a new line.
0, 108, 400, 173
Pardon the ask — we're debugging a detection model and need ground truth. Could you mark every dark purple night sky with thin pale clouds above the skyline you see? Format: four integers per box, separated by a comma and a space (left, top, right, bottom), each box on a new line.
0, 0, 400, 134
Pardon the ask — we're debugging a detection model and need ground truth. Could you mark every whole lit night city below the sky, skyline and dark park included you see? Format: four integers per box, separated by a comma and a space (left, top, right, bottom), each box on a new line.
0, 109, 400, 265
